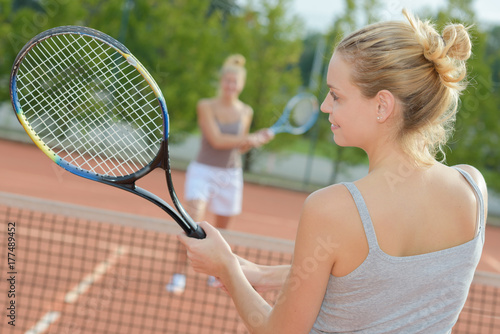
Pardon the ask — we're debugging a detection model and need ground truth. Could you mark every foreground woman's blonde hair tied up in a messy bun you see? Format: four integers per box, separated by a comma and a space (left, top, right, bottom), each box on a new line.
336, 10, 472, 165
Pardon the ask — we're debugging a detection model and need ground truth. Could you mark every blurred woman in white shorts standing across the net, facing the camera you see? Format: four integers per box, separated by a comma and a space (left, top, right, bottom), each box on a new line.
166, 54, 273, 293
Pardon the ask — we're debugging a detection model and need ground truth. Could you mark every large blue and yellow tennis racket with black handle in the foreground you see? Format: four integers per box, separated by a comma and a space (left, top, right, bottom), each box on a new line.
10, 26, 205, 239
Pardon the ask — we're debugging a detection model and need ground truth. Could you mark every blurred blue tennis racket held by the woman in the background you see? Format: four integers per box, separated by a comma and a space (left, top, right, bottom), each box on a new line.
269, 93, 319, 135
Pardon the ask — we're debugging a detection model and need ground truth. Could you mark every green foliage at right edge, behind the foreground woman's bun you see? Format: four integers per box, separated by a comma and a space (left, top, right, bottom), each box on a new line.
437, 0, 500, 190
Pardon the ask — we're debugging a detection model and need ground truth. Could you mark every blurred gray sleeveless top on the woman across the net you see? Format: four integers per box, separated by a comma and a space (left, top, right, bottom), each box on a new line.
196, 120, 241, 168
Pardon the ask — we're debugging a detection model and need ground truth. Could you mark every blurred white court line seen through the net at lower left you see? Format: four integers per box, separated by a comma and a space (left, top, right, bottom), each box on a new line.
25, 246, 127, 334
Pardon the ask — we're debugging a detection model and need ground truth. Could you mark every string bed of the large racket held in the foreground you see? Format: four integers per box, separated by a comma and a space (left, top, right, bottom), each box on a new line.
18, 35, 163, 176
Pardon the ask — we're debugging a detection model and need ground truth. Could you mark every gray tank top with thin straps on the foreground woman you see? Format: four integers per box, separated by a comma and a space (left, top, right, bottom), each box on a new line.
310, 168, 485, 334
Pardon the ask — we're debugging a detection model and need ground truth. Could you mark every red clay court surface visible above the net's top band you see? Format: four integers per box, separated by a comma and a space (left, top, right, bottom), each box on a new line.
0, 140, 500, 273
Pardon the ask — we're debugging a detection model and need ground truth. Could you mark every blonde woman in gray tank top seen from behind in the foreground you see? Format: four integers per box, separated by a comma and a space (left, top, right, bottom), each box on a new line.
179, 11, 487, 334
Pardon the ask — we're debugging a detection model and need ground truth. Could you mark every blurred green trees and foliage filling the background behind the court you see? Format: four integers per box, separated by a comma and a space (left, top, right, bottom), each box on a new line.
0, 0, 500, 190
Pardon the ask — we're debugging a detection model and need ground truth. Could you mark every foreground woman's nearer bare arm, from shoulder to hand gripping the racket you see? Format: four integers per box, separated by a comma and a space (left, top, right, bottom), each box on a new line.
179, 188, 338, 334
